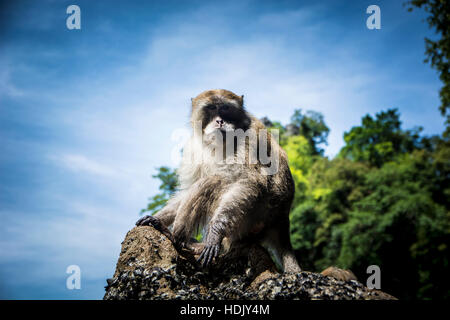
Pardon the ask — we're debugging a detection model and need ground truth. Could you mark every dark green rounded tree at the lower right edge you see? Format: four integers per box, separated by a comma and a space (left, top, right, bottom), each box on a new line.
340, 150, 450, 299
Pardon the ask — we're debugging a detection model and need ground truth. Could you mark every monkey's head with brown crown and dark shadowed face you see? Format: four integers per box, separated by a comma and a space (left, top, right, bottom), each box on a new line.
192, 90, 250, 135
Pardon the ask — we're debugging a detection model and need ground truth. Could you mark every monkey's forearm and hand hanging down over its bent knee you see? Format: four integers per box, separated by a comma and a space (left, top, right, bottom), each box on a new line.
198, 182, 258, 267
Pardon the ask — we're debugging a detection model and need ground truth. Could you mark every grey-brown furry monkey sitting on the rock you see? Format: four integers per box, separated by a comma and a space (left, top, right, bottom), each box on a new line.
136, 89, 301, 272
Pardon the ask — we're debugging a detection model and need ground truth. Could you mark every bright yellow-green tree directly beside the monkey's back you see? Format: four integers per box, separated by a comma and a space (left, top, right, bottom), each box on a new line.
291, 158, 370, 270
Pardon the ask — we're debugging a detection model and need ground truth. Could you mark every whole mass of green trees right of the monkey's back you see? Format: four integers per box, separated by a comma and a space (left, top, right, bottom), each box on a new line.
288, 110, 450, 299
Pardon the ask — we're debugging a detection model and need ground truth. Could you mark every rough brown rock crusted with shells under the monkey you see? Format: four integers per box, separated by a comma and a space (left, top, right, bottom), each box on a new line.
104, 226, 395, 300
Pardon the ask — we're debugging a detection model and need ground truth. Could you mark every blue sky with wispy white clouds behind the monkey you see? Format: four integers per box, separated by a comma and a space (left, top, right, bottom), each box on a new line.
0, 0, 444, 299
